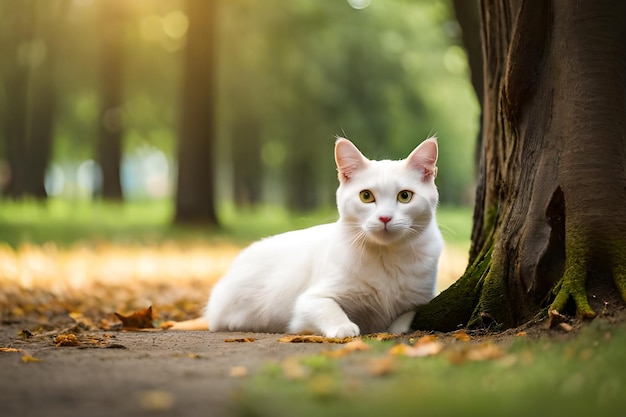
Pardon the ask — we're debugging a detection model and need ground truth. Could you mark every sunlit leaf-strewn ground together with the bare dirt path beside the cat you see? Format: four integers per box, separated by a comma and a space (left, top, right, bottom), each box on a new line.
0, 243, 466, 417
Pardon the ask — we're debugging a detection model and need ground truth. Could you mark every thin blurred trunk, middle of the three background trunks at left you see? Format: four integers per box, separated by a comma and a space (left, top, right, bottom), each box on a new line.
96, 0, 126, 201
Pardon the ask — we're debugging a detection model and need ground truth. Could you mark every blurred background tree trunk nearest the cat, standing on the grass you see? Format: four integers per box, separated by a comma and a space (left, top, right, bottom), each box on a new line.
175, 0, 217, 225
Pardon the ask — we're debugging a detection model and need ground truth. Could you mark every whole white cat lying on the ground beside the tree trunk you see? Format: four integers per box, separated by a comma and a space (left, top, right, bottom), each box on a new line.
204, 138, 443, 338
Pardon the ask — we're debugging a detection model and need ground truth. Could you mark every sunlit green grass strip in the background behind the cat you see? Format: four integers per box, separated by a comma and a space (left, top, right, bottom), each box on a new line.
0, 199, 471, 248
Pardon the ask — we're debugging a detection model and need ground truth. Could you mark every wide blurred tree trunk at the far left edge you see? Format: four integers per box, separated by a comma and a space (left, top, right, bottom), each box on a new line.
2, 1, 59, 199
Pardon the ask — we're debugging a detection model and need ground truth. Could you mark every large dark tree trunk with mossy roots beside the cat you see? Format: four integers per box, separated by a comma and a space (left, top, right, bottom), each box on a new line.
413, 0, 626, 330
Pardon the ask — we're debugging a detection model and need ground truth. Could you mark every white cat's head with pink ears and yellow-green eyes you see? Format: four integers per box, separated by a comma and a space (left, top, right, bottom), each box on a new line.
335, 137, 439, 245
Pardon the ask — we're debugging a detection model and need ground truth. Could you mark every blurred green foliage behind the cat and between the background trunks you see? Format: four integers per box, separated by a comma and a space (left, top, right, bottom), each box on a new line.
0, 0, 479, 208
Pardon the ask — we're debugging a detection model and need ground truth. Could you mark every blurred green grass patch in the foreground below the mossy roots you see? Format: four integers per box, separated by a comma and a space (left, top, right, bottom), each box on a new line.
239, 320, 626, 417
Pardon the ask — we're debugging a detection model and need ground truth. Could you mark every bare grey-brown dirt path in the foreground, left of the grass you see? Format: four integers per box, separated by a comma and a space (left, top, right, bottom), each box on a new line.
0, 325, 336, 417
